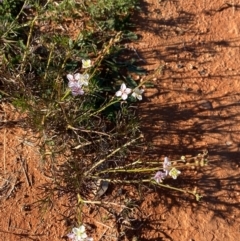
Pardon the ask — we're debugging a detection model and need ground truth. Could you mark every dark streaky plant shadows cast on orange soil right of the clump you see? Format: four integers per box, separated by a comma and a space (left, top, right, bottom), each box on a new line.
127, 1, 240, 240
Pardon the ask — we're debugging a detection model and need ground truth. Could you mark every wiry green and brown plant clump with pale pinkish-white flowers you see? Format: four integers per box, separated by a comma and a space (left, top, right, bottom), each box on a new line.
0, 0, 207, 240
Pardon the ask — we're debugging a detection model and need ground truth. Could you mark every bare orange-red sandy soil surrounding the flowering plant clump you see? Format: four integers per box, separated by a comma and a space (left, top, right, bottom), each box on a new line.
0, 0, 240, 241
